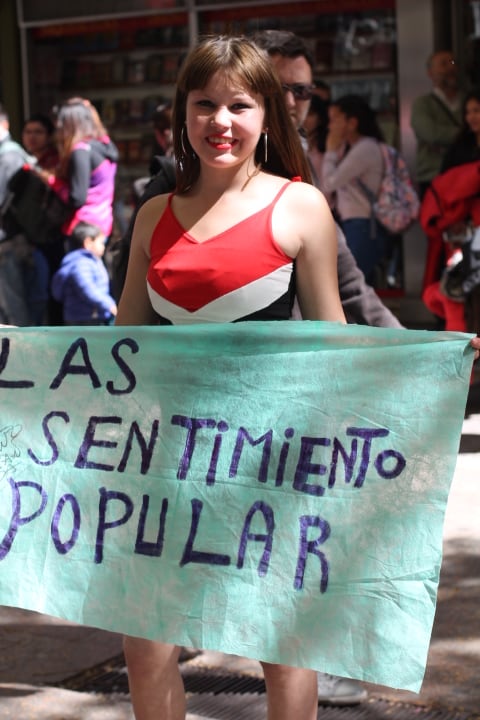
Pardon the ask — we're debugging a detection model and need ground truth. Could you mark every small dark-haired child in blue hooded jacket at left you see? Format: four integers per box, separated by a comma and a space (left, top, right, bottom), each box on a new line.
52, 222, 117, 325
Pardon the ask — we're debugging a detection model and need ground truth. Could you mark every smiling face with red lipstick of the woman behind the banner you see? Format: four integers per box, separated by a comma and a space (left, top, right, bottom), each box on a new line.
186, 73, 265, 167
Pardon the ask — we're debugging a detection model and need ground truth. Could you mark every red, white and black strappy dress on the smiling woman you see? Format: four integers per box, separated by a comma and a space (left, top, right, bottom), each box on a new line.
147, 182, 294, 325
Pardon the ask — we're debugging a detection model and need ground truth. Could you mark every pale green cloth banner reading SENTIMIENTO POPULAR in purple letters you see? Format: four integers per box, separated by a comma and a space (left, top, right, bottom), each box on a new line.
0, 322, 474, 691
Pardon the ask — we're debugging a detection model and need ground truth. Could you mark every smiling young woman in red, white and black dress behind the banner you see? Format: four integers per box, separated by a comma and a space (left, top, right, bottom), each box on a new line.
116, 37, 344, 720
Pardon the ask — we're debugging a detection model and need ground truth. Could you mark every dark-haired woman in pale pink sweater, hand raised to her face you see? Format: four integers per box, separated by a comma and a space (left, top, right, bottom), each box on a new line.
322, 95, 387, 283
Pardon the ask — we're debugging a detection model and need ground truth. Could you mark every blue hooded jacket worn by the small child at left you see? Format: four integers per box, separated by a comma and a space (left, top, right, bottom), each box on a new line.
52, 248, 115, 325
